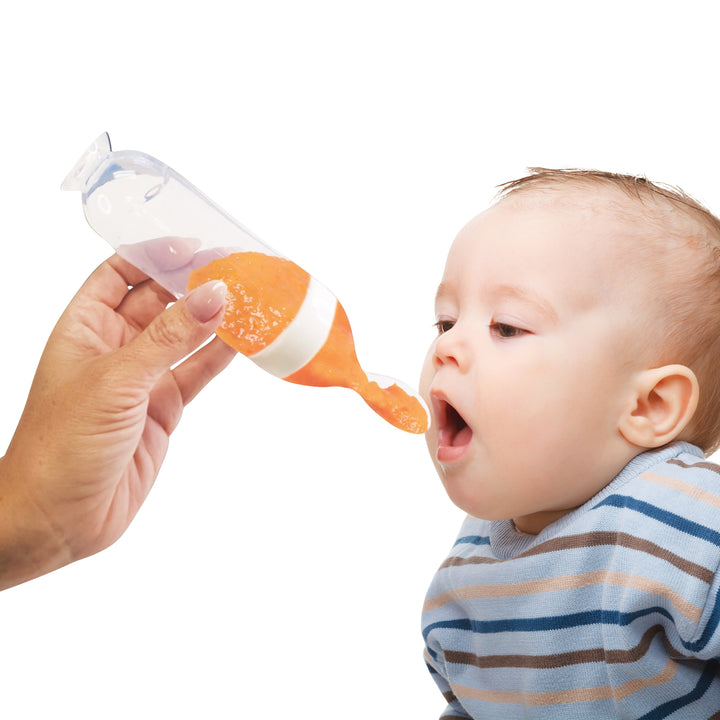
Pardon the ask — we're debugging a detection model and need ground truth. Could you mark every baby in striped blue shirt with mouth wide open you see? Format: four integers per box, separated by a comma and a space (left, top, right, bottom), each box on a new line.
421, 169, 720, 720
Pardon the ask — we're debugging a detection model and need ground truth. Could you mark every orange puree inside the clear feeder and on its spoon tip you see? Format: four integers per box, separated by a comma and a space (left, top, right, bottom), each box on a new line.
188, 252, 428, 433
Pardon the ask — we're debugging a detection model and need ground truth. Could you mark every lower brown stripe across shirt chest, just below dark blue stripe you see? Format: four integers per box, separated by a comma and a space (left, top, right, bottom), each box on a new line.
444, 625, 663, 670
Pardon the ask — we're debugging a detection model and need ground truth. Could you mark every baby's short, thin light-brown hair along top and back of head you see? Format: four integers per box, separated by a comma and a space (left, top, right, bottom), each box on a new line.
497, 168, 720, 455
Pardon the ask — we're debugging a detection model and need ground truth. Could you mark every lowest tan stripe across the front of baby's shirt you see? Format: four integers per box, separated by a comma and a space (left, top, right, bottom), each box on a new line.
453, 659, 677, 707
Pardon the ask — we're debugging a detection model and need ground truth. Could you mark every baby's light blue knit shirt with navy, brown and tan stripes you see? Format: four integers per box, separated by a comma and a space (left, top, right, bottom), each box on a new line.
423, 443, 720, 720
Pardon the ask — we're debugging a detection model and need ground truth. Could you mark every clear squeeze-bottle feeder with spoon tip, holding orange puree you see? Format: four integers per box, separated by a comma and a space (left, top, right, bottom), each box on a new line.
61, 133, 429, 433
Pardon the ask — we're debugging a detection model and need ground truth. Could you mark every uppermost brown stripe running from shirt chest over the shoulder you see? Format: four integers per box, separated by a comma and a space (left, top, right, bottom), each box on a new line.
440, 532, 713, 585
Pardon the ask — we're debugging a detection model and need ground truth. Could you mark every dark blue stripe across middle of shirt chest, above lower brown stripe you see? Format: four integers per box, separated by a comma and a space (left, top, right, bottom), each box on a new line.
423, 607, 672, 639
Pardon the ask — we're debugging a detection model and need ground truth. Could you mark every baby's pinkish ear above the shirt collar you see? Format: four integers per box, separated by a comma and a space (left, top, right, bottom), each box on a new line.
618, 365, 700, 448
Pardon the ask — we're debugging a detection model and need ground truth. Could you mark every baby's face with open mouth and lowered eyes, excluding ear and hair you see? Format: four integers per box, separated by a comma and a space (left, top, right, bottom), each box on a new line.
421, 195, 652, 533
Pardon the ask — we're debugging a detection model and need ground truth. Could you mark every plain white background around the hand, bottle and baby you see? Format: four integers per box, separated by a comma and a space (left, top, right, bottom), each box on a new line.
0, 0, 720, 720
